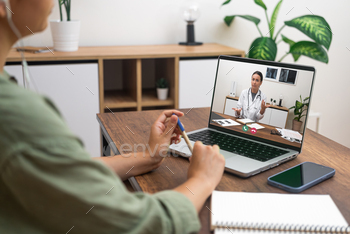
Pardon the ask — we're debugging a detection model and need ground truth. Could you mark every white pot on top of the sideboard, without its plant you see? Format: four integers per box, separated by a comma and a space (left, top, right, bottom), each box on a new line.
50, 20, 80, 52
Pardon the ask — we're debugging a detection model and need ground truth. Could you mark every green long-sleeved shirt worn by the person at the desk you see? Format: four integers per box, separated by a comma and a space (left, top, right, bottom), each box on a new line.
0, 73, 200, 234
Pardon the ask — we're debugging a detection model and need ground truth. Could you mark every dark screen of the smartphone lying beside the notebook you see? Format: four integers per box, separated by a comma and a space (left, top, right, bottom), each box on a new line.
270, 163, 334, 188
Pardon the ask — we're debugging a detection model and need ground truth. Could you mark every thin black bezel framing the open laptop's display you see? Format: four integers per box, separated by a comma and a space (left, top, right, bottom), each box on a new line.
208, 55, 316, 153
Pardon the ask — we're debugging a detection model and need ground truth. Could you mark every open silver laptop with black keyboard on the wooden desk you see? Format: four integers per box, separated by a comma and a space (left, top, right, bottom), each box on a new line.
169, 56, 315, 177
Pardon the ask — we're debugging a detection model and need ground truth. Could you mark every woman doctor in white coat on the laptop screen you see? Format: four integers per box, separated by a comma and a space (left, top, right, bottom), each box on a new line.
232, 71, 270, 122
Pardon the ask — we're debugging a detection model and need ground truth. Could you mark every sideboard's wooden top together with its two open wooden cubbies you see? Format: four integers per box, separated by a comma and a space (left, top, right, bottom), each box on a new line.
6, 43, 245, 113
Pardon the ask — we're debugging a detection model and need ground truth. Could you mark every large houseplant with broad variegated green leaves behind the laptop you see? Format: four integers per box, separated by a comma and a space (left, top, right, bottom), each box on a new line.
222, 0, 332, 63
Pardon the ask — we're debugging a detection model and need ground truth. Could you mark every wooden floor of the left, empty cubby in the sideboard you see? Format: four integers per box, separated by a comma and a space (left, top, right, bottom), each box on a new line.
104, 90, 137, 109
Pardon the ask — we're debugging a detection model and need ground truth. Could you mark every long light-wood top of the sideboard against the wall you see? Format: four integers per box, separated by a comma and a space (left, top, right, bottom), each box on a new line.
7, 43, 245, 62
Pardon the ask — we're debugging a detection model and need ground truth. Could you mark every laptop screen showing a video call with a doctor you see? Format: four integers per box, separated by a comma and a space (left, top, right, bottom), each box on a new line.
209, 56, 315, 152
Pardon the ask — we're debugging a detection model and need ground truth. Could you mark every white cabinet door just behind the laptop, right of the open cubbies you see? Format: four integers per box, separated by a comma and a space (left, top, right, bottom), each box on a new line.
179, 59, 217, 108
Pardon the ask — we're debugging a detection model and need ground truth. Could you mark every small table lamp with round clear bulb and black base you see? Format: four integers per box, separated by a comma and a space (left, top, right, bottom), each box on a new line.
179, 5, 203, 46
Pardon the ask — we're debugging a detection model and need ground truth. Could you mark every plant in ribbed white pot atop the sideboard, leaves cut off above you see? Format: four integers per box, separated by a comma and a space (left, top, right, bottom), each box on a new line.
50, 0, 80, 52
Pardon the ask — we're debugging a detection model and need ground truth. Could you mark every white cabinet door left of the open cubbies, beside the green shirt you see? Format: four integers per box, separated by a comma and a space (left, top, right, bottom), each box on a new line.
29, 63, 101, 156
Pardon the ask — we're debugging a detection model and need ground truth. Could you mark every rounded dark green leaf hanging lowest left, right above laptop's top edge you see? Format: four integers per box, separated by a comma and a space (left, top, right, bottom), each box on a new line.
248, 37, 277, 61
